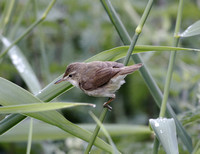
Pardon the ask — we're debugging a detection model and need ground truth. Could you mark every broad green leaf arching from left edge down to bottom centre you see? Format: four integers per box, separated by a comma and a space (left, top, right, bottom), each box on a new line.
0, 77, 111, 151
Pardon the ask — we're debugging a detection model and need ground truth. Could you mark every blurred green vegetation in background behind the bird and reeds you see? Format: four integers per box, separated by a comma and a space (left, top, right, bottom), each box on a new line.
0, 0, 200, 153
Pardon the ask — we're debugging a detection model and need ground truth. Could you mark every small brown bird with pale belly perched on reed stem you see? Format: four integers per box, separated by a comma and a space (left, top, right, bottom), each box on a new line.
55, 61, 143, 110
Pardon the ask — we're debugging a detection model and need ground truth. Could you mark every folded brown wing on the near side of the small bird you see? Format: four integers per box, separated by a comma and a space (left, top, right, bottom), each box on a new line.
81, 67, 120, 90
